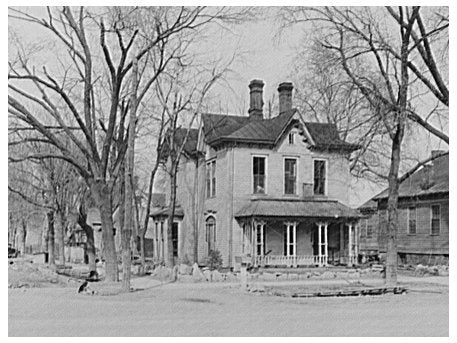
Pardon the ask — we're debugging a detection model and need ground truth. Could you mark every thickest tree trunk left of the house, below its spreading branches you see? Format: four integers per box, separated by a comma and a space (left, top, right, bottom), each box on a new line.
91, 181, 119, 281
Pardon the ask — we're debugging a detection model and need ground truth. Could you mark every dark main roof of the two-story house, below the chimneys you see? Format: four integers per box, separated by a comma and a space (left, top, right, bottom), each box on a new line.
202, 109, 359, 151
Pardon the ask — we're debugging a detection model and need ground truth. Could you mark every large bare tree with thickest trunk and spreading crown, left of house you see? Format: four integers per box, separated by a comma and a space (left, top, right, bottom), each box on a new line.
8, 7, 251, 280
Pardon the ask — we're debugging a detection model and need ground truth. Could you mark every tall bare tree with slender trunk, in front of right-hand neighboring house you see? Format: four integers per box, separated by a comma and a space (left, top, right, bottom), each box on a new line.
280, 7, 449, 283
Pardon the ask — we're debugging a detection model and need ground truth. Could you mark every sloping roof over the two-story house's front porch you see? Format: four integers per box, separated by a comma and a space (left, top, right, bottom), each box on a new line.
235, 199, 361, 218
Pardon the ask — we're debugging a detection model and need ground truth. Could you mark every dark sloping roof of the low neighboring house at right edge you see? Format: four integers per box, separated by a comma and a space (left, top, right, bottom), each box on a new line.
373, 153, 449, 200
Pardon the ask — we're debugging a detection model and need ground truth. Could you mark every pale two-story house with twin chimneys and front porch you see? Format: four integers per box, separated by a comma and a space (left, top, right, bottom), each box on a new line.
148, 80, 359, 267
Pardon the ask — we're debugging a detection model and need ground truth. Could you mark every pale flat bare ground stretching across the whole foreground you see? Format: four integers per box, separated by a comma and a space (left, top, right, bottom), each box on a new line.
8, 277, 449, 336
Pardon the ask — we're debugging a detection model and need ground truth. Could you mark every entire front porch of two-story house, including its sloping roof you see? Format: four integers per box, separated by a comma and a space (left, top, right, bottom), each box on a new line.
235, 197, 360, 267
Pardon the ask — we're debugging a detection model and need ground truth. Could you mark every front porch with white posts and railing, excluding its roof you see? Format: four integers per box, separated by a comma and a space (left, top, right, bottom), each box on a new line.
243, 218, 358, 267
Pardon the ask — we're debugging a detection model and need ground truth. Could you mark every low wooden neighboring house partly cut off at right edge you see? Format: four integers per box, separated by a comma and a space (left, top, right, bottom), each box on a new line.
359, 151, 449, 264
